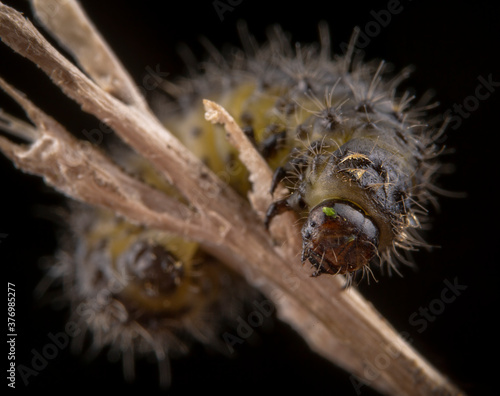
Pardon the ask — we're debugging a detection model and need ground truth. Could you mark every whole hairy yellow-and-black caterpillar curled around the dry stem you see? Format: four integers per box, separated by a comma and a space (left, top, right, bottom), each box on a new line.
0, 16, 442, 384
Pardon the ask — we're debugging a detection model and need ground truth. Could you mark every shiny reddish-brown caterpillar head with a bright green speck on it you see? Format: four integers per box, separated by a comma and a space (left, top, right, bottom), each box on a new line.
302, 200, 379, 276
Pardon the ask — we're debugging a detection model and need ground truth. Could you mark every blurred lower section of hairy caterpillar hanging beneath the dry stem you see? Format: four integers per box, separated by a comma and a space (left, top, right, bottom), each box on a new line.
38, 206, 257, 387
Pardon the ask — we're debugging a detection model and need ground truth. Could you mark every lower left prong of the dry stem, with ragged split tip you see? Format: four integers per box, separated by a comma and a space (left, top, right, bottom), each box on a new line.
0, 78, 206, 239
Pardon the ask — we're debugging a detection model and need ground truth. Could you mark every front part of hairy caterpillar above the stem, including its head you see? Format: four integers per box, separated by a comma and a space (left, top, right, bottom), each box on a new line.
158, 24, 444, 282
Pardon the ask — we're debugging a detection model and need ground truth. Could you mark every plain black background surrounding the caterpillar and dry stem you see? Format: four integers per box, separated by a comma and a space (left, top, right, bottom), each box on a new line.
0, 0, 500, 395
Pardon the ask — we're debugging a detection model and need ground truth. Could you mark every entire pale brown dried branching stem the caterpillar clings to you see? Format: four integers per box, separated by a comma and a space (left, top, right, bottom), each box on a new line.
0, 1, 460, 395
